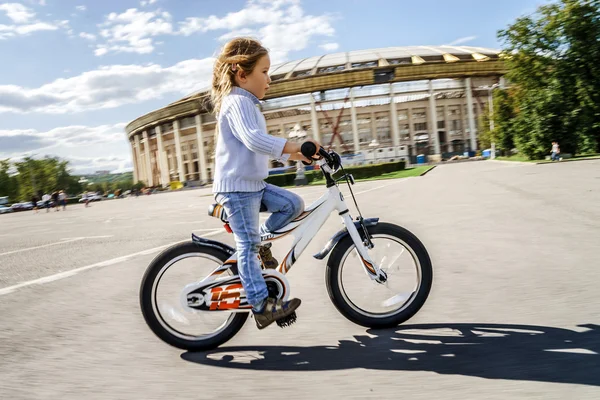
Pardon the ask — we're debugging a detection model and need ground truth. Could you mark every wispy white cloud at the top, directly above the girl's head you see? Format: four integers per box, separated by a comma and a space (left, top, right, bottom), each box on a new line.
177, 0, 335, 63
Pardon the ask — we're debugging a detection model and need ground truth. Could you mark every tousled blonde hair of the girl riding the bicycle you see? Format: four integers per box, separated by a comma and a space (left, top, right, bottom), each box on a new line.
210, 37, 269, 114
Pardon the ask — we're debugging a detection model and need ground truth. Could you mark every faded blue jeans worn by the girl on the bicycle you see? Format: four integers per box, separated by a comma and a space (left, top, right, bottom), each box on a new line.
215, 184, 304, 307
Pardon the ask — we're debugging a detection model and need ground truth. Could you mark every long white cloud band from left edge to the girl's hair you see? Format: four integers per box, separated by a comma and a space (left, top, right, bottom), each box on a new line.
0, 58, 214, 114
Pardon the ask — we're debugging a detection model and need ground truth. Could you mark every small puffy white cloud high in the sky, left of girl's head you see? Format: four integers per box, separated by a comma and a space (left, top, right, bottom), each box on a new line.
95, 8, 173, 56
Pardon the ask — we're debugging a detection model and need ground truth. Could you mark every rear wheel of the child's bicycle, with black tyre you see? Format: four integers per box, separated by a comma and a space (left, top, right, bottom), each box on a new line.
140, 242, 248, 351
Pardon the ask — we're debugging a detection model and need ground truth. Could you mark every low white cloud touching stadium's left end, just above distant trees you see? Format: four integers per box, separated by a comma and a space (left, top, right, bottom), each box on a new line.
0, 123, 131, 173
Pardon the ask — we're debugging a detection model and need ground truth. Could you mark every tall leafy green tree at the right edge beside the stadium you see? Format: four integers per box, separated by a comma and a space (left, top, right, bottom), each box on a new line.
494, 0, 600, 158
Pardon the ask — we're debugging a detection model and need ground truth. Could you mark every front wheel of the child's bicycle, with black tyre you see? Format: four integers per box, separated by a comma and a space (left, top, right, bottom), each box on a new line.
326, 223, 433, 328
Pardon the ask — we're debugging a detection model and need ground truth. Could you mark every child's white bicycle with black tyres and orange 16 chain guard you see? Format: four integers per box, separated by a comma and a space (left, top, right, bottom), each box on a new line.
140, 142, 433, 351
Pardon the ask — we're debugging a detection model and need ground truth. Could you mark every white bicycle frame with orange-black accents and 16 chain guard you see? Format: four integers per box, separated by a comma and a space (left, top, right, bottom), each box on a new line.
181, 160, 383, 311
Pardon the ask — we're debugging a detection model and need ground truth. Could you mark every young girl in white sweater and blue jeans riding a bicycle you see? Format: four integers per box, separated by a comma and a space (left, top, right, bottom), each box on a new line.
211, 38, 320, 329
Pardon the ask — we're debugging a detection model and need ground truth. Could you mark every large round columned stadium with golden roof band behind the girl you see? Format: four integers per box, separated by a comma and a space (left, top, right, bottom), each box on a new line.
126, 46, 506, 186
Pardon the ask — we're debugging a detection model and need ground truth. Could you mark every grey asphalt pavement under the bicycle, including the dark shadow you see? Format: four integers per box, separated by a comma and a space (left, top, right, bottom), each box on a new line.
0, 161, 600, 400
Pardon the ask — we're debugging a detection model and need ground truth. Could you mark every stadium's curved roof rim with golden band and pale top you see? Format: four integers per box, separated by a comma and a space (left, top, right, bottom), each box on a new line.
125, 46, 506, 134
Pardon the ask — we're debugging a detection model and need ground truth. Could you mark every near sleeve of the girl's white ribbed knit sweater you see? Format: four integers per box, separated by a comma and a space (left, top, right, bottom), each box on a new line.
225, 96, 287, 159
